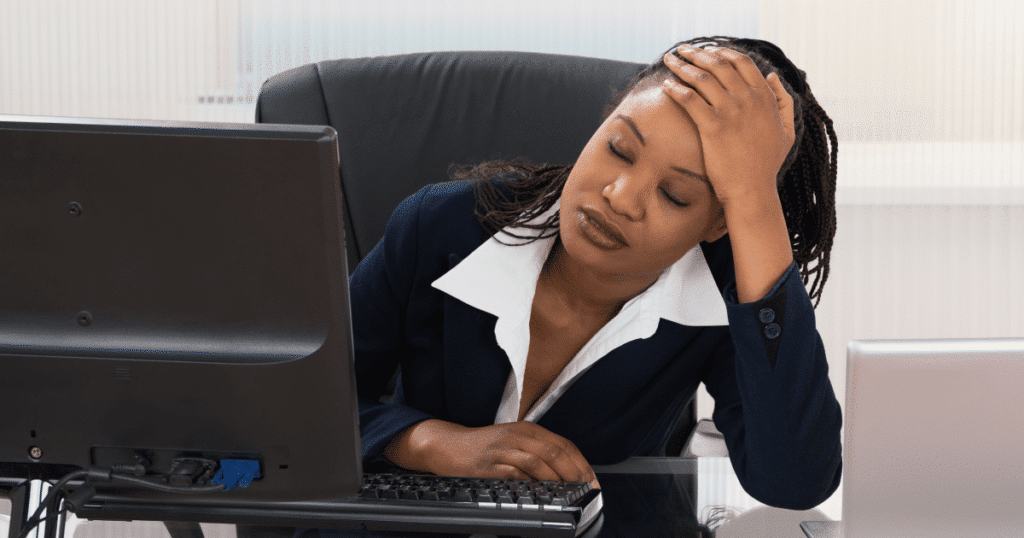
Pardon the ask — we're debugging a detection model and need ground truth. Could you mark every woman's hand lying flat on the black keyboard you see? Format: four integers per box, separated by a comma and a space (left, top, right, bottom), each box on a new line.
384, 420, 600, 489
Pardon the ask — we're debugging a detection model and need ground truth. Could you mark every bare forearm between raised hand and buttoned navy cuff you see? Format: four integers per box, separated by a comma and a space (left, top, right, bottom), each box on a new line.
723, 184, 793, 303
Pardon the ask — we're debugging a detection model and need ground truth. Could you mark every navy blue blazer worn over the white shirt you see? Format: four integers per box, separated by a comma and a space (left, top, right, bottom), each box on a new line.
349, 181, 842, 509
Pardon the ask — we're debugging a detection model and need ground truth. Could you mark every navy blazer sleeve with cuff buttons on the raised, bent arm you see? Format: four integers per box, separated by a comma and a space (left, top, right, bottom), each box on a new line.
701, 263, 843, 509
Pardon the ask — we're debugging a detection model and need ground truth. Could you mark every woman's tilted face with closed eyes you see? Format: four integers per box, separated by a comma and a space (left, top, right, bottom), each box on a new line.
559, 85, 725, 278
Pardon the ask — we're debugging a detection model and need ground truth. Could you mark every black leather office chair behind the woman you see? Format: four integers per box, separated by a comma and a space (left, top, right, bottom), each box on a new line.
256, 51, 696, 456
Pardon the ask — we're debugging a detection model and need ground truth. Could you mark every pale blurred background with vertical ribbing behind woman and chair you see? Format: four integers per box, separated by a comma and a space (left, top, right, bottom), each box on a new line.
0, 0, 1024, 520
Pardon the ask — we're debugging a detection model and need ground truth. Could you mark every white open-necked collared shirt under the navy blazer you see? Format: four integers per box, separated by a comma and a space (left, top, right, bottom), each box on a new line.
432, 202, 729, 424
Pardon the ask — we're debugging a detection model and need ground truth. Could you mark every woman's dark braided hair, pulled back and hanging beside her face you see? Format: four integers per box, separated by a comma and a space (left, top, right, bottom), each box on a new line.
464, 36, 839, 306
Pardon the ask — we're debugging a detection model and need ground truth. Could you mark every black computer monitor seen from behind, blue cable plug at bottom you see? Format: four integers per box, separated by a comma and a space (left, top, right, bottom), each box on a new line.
0, 117, 361, 504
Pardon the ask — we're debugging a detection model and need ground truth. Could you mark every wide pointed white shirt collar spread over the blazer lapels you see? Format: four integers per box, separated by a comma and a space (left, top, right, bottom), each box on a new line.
432, 202, 729, 327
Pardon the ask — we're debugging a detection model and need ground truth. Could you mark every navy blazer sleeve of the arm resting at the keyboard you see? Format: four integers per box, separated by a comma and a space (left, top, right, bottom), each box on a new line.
349, 185, 433, 459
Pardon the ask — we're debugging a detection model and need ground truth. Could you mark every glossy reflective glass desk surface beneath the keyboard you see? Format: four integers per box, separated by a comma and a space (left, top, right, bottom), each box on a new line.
0, 457, 842, 538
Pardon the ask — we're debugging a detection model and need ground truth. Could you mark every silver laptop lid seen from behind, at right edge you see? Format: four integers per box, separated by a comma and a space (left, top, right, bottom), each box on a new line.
801, 338, 1024, 538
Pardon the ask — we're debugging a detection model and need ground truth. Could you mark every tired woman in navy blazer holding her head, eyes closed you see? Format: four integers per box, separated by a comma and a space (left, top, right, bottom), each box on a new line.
350, 38, 842, 509
